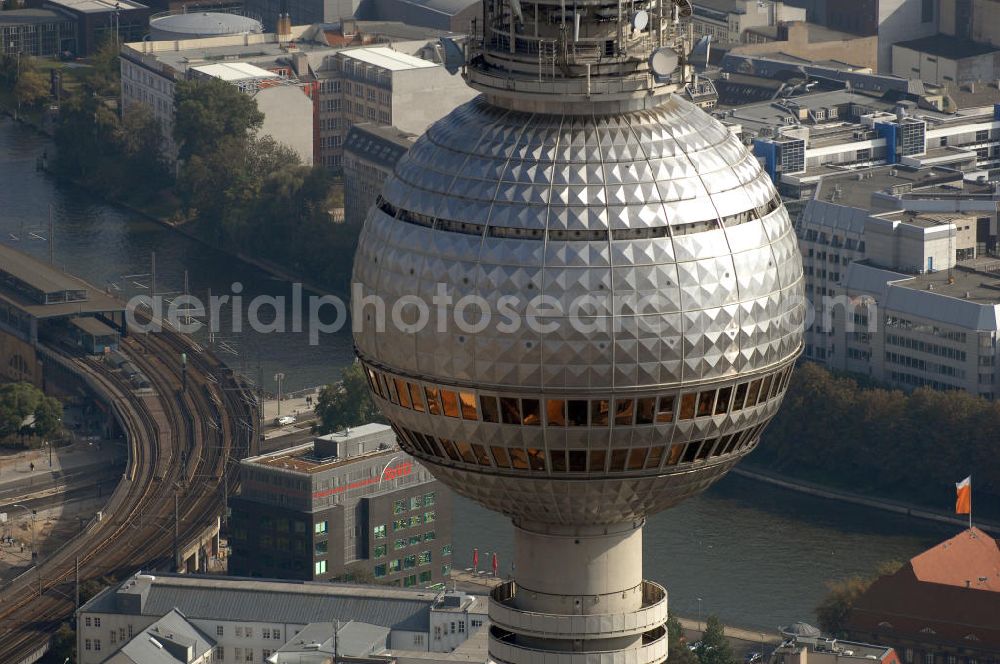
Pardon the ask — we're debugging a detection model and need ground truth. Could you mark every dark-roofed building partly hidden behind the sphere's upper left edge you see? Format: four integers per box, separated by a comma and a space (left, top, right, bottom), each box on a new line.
344, 122, 417, 226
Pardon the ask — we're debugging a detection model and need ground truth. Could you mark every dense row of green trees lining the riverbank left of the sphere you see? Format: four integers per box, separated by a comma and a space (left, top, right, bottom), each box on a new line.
47, 45, 356, 288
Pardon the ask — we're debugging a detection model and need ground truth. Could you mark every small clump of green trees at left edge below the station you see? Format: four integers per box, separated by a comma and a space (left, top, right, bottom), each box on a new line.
0, 383, 62, 447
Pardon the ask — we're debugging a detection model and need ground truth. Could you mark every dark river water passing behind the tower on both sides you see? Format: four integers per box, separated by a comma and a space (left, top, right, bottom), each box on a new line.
0, 118, 957, 629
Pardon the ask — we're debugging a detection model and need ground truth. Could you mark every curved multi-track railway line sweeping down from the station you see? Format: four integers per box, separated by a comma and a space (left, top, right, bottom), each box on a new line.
0, 324, 257, 663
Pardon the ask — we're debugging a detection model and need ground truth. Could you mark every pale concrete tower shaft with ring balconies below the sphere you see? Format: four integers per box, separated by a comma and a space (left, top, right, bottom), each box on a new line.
489, 521, 667, 664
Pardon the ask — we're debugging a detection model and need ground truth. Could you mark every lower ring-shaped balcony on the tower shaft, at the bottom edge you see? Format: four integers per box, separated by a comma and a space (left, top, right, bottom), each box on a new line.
489, 626, 667, 664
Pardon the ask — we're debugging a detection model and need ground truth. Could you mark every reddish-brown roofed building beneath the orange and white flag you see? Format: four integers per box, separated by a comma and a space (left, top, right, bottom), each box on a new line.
846, 528, 1000, 664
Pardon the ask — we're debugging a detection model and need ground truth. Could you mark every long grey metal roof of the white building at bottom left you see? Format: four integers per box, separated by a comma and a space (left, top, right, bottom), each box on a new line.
81, 574, 444, 632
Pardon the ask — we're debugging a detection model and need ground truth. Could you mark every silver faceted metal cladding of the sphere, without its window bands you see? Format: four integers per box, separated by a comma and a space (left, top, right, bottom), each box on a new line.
354, 91, 804, 524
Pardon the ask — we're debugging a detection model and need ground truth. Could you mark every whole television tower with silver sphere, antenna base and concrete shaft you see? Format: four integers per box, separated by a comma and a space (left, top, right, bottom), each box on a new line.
353, 0, 804, 664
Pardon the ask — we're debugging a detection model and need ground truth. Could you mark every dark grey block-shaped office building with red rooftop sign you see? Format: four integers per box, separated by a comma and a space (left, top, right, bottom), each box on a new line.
229, 424, 451, 587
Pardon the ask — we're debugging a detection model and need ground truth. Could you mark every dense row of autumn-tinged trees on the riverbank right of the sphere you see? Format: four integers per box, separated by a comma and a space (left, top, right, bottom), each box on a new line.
750, 363, 1000, 514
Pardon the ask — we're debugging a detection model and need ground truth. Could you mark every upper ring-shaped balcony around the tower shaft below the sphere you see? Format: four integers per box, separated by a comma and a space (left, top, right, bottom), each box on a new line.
489, 581, 667, 639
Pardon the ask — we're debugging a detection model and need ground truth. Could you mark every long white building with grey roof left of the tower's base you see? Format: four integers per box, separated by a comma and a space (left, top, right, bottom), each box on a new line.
76, 574, 487, 664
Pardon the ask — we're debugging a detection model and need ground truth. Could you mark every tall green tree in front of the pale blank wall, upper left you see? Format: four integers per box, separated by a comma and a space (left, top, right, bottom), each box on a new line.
174, 78, 264, 160
